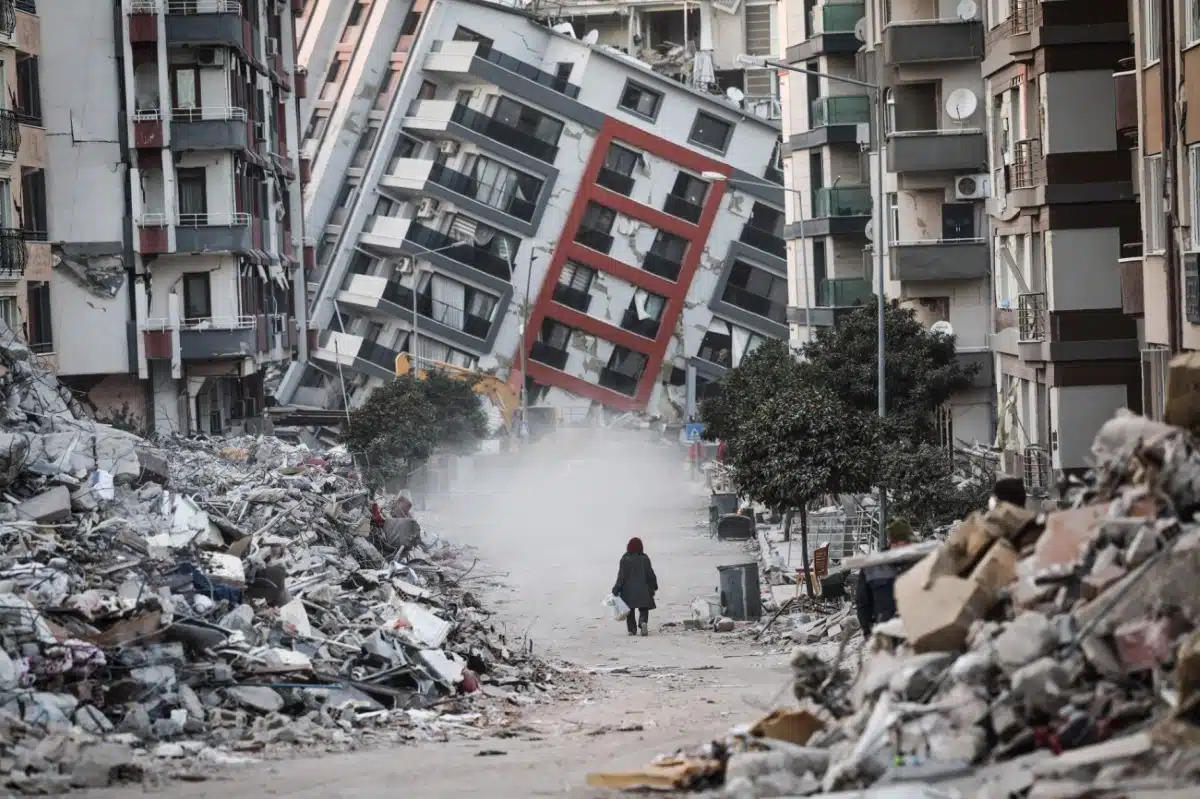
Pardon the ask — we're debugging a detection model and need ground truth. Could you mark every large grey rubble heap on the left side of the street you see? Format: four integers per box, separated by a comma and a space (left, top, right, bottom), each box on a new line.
0, 330, 572, 794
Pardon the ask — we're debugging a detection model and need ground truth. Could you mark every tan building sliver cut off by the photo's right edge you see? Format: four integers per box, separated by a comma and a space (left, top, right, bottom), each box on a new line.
1128, 0, 1200, 419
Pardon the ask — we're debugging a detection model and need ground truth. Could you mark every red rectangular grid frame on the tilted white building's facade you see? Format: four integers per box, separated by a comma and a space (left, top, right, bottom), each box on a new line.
512, 116, 732, 410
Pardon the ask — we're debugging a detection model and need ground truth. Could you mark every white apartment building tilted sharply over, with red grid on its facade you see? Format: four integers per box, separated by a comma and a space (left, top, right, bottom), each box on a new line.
281, 0, 786, 417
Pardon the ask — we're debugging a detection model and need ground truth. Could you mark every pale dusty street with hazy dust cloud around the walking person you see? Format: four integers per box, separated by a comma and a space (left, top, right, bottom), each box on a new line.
84, 434, 788, 799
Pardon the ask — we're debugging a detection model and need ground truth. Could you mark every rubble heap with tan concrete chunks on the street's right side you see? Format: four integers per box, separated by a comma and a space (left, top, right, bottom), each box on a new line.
589, 411, 1200, 799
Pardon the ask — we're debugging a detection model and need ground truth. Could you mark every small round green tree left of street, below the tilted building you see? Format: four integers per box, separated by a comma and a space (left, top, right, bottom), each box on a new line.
343, 372, 487, 486
